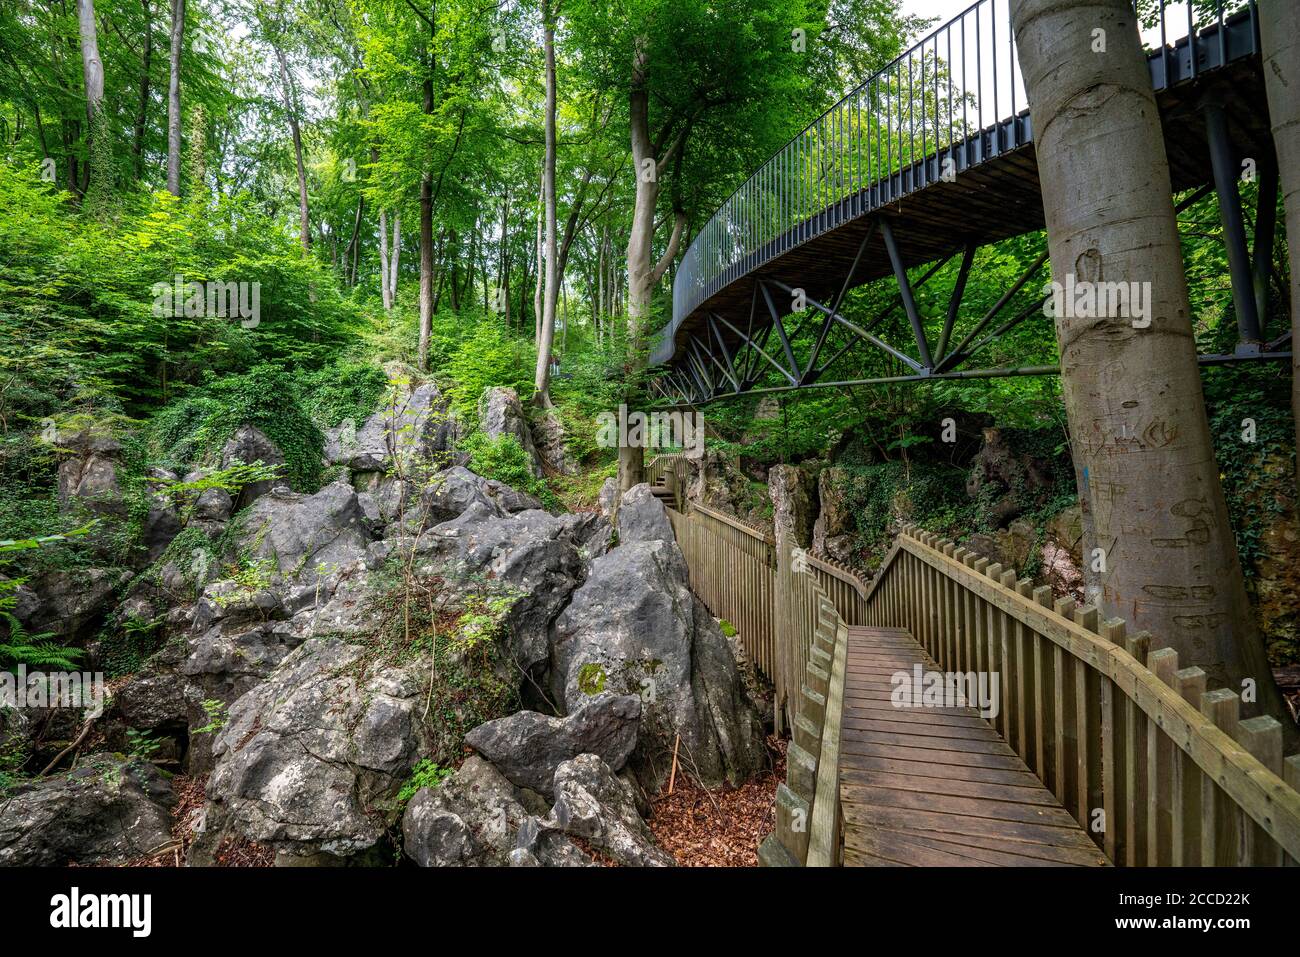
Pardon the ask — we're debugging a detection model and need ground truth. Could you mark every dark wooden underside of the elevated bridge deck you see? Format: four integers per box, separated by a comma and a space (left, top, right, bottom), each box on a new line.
658, 57, 1273, 361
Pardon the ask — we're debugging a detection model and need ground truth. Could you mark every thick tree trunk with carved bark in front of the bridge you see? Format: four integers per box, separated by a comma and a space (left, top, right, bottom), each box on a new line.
1011, 0, 1295, 729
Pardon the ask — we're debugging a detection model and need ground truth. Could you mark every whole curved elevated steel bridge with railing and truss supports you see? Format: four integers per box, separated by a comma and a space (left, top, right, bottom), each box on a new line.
650, 0, 1290, 404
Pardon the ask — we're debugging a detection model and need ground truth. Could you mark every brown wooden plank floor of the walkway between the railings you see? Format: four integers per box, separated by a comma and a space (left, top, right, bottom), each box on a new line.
840, 627, 1110, 867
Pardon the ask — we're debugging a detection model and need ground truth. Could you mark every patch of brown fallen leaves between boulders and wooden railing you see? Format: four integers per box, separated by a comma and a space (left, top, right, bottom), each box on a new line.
649, 737, 785, 867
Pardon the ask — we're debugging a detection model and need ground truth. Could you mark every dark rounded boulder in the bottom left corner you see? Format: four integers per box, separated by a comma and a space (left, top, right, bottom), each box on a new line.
0, 754, 176, 867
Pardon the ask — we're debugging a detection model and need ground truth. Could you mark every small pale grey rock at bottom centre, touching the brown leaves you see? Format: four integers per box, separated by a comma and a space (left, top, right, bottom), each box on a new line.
541, 754, 676, 867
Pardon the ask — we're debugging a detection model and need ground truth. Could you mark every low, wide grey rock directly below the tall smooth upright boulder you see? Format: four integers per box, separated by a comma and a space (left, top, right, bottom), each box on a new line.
465, 694, 641, 796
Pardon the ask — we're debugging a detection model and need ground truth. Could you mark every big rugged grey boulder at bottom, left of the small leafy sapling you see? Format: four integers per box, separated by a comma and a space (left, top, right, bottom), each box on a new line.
207, 638, 429, 858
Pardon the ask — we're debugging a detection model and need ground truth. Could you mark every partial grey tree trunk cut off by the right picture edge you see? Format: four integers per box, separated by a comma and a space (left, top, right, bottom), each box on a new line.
1260, 3, 1300, 507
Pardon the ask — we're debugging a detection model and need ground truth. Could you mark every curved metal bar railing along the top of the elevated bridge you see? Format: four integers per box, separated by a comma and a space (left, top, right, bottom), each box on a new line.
655, 0, 1256, 361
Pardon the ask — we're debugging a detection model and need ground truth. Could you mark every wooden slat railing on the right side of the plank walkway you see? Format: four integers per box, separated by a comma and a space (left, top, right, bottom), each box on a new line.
867, 528, 1300, 866
